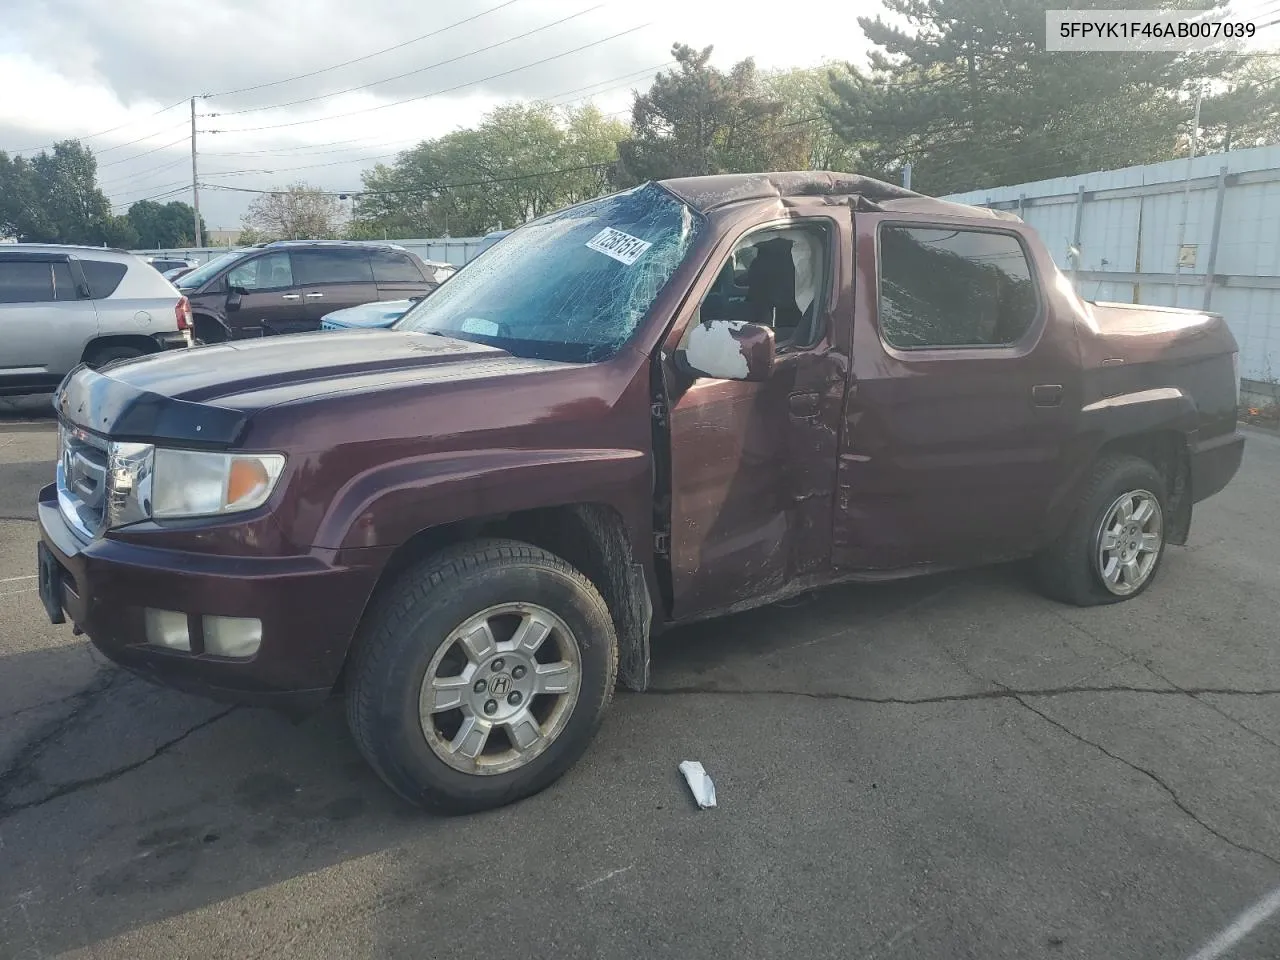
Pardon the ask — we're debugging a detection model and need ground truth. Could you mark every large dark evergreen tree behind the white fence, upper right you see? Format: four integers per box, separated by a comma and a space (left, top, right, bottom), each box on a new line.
824, 0, 1249, 193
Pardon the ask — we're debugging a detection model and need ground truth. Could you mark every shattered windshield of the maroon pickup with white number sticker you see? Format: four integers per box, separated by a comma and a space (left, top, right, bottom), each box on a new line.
396, 183, 701, 362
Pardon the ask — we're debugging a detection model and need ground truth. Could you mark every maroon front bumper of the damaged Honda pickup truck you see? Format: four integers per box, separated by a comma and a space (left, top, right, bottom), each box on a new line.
38, 485, 381, 713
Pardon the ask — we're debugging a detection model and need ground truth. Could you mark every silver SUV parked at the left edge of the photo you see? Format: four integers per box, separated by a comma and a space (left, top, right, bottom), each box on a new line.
0, 243, 191, 396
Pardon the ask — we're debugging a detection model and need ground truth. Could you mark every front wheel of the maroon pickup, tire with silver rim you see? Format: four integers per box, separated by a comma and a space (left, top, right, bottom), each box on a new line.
347, 540, 618, 814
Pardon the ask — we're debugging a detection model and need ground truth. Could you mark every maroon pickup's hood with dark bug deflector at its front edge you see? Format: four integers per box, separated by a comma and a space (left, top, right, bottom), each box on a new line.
54, 330, 564, 445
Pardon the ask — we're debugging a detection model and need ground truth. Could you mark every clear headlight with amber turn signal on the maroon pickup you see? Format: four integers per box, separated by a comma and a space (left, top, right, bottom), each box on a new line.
151, 447, 284, 520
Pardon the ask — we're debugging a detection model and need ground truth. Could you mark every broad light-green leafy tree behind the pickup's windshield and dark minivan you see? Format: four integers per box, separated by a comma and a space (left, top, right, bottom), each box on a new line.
352, 102, 627, 238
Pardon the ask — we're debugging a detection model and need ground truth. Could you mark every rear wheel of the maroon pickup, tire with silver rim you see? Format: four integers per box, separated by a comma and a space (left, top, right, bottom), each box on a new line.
1033, 456, 1170, 607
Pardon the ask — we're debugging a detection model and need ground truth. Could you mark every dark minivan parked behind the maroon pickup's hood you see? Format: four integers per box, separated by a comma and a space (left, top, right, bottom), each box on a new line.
177, 241, 439, 343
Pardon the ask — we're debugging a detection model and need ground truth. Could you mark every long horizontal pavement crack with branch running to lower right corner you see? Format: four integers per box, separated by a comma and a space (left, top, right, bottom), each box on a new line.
646, 686, 1280, 867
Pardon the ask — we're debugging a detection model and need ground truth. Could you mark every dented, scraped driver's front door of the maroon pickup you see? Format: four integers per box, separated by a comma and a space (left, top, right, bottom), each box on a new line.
666, 207, 851, 620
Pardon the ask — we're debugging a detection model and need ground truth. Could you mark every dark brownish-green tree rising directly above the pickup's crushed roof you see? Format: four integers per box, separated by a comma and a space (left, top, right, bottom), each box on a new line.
618, 44, 808, 184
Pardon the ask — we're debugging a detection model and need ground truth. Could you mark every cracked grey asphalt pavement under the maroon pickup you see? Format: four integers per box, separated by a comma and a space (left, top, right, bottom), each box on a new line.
0, 421, 1280, 960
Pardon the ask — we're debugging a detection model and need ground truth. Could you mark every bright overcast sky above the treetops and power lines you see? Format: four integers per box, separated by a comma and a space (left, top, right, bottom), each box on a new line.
0, 0, 879, 238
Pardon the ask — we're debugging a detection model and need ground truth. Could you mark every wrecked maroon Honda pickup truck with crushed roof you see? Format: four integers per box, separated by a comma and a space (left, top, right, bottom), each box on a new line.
38, 173, 1243, 810
